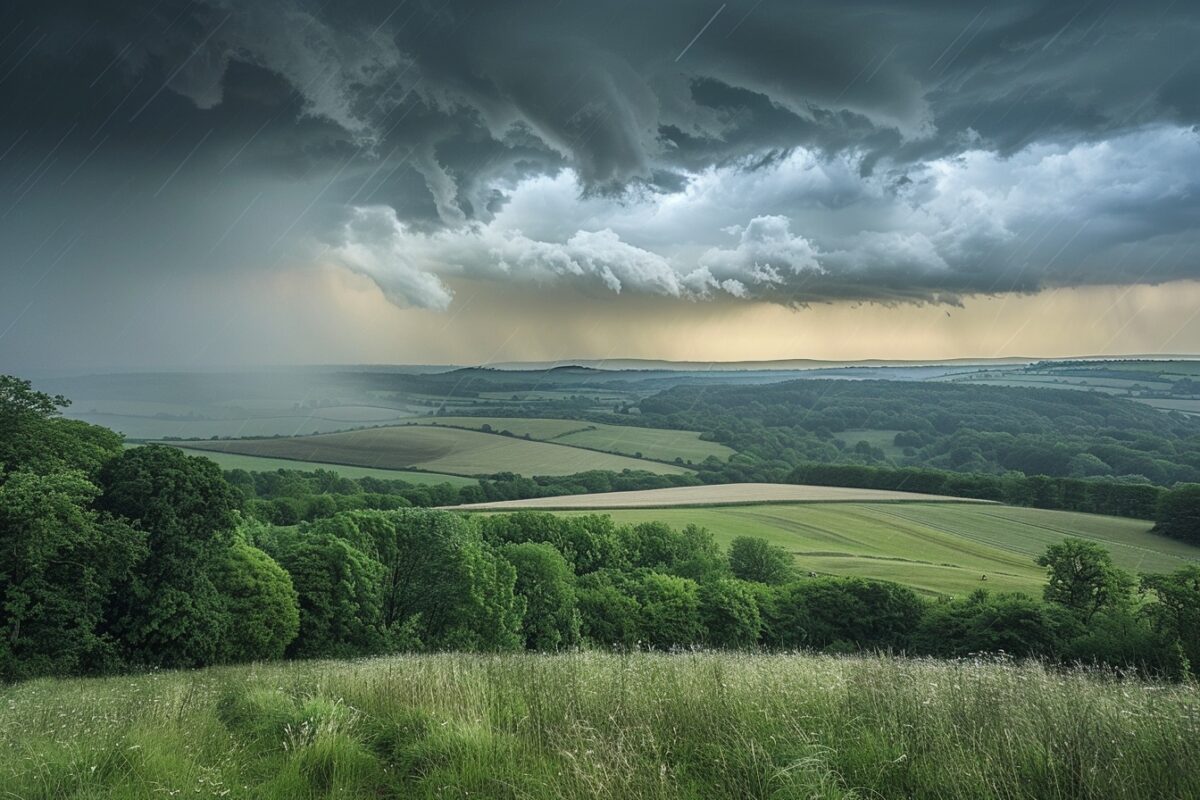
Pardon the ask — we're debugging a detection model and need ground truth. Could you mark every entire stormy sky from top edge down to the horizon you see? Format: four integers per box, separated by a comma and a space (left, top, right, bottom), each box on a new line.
0, 0, 1200, 371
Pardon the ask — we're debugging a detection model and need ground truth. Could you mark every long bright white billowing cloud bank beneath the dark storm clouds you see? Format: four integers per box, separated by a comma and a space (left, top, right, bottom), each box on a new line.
324, 128, 1200, 308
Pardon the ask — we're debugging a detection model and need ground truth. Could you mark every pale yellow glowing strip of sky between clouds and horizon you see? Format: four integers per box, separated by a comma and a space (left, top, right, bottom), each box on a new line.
220, 267, 1200, 363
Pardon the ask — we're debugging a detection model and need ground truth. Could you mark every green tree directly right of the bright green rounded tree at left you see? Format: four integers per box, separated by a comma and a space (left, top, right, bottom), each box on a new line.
263, 528, 384, 657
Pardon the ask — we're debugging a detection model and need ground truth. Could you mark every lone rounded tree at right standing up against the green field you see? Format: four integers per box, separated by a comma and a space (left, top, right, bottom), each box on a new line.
1037, 539, 1134, 622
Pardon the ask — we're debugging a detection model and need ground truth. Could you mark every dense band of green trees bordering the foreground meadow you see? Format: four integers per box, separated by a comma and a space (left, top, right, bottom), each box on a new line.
0, 378, 1200, 680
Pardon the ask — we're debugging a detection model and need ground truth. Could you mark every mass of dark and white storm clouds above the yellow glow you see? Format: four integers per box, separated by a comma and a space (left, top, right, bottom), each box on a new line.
0, 0, 1200, 309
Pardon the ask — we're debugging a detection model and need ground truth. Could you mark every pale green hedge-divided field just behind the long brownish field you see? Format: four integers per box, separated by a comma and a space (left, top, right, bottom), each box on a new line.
421, 416, 739, 464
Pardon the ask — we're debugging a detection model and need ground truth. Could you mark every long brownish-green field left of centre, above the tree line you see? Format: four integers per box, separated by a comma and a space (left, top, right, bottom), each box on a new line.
174, 425, 686, 475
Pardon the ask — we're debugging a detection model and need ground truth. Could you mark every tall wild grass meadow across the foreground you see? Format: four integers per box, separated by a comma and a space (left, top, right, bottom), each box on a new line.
0, 654, 1200, 799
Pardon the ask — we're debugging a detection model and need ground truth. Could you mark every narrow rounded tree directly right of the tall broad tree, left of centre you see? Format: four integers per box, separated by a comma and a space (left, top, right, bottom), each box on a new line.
500, 542, 580, 651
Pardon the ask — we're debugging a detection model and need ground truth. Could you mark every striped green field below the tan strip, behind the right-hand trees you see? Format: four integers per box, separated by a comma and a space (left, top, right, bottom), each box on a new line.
556, 503, 1200, 595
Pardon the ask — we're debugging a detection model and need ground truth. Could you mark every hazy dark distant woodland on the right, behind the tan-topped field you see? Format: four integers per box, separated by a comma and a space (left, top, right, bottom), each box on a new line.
625, 380, 1200, 486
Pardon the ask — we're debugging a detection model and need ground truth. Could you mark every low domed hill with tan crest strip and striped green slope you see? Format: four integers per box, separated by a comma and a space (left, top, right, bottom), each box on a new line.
453, 485, 1200, 594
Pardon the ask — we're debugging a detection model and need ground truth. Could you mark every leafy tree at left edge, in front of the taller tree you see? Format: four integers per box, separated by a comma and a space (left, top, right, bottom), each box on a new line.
0, 471, 143, 680
